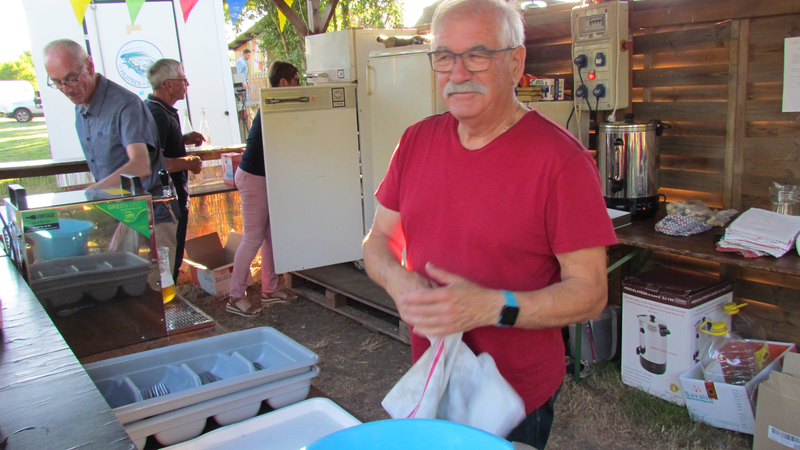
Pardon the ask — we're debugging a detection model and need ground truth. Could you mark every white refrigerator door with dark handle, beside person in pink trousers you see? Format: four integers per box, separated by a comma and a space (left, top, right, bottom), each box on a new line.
261, 83, 364, 273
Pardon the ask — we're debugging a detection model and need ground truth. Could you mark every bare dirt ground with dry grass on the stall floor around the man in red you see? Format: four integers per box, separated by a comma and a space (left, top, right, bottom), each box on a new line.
179, 278, 752, 450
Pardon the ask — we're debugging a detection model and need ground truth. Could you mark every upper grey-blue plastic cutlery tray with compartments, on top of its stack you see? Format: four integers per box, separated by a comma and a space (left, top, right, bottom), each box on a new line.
84, 327, 318, 425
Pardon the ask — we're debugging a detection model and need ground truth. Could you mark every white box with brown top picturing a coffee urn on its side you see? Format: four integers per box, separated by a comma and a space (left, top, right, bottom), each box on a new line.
622, 267, 733, 405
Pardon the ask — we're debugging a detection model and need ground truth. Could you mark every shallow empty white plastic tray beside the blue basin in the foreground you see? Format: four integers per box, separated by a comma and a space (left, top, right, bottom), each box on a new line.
169, 398, 361, 450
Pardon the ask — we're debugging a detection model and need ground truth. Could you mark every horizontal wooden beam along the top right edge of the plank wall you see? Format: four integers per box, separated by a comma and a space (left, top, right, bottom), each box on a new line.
630, 0, 800, 30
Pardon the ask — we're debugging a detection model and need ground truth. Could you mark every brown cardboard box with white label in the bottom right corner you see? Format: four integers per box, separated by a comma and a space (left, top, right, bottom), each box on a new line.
753, 353, 800, 450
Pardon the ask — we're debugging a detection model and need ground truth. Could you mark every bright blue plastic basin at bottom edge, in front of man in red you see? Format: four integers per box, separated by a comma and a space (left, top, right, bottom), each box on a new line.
305, 419, 514, 450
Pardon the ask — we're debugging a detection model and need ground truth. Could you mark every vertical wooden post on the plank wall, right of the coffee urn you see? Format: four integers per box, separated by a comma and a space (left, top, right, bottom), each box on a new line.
722, 19, 750, 211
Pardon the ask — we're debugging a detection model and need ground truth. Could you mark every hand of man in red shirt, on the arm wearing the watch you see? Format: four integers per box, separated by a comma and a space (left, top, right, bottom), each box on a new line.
396, 263, 505, 336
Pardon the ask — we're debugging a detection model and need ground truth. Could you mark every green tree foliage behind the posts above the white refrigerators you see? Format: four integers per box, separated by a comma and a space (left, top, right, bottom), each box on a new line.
234, 0, 403, 72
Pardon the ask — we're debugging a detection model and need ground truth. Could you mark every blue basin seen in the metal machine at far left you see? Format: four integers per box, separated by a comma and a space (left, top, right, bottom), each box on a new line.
26, 219, 94, 262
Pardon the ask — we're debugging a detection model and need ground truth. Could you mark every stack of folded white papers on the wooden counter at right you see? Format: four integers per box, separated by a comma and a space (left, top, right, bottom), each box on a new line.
719, 208, 800, 257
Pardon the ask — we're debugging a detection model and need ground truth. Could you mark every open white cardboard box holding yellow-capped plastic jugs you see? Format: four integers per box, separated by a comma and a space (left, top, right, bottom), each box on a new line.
681, 342, 800, 434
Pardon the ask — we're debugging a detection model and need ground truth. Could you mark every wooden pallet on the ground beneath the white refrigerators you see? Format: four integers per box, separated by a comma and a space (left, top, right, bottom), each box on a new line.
284, 263, 411, 344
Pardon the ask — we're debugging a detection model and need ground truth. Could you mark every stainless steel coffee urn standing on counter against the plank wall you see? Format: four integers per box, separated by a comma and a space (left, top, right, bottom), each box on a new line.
597, 114, 669, 219
